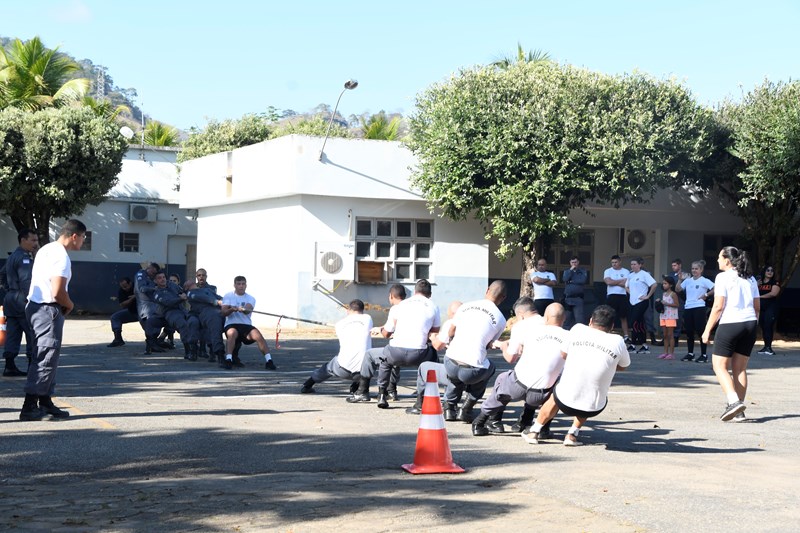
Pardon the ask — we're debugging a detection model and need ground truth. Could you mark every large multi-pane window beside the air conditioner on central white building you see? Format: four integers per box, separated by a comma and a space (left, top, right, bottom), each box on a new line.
356, 218, 434, 282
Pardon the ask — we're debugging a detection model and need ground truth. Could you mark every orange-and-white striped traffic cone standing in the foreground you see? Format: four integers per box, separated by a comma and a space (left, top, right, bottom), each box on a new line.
403, 370, 464, 474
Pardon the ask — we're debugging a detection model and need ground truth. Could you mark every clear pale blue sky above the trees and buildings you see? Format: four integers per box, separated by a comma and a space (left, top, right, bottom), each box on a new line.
0, 0, 800, 129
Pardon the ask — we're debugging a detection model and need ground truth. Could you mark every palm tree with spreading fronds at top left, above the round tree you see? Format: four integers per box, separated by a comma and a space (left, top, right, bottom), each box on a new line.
0, 37, 89, 111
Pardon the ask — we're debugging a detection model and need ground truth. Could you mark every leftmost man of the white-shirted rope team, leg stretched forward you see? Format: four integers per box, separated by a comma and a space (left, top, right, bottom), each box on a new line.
300, 300, 372, 394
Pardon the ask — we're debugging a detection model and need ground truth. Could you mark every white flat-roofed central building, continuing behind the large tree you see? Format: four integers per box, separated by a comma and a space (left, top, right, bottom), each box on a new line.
180, 135, 741, 324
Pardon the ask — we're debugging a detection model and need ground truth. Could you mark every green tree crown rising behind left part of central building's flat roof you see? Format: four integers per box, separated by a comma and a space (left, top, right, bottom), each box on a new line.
178, 112, 276, 163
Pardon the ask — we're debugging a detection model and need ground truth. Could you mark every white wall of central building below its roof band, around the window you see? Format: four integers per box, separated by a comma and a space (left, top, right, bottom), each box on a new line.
197, 196, 488, 327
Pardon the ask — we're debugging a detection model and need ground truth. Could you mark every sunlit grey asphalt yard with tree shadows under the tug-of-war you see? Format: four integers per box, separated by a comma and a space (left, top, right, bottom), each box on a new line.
0, 318, 800, 532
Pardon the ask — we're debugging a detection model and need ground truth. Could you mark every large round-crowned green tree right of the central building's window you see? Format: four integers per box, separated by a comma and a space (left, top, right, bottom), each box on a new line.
406, 62, 711, 296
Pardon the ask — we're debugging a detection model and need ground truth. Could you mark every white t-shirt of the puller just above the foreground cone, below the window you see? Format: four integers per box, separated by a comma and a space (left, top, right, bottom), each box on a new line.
383, 294, 441, 350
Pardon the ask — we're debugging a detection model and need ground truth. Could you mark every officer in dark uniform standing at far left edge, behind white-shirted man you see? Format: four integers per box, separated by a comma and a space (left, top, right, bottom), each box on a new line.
2, 228, 39, 377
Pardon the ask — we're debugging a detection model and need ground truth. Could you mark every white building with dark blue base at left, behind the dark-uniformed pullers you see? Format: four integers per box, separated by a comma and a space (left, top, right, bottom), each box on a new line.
0, 145, 197, 313
